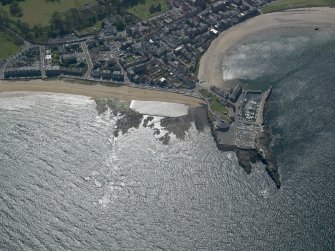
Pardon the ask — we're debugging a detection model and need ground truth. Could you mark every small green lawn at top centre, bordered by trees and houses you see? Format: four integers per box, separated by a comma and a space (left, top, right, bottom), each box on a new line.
127, 0, 170, 20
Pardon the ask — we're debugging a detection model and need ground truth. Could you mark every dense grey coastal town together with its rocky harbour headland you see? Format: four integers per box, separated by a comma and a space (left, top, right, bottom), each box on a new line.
0, 0, 280, 188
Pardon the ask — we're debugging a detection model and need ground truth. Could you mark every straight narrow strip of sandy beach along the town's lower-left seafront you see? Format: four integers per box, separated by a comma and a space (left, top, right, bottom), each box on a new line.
0, 79, 204, 106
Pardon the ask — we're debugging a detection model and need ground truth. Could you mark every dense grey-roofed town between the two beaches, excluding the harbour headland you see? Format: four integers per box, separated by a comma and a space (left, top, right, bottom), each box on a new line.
0, 0, 269, 88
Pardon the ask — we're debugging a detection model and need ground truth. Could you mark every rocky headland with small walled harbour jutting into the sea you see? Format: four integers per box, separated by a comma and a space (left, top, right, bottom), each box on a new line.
200, 86, 281, 188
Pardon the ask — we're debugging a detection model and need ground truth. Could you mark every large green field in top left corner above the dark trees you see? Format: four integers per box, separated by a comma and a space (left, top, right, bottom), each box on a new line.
0, 0, 96, 26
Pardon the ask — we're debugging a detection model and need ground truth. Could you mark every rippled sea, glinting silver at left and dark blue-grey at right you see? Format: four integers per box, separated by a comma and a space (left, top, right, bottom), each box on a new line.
0, 26, 335, 251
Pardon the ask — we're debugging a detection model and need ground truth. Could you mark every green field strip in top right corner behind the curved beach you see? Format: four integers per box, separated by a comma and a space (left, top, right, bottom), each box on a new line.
262, 0, 335, 13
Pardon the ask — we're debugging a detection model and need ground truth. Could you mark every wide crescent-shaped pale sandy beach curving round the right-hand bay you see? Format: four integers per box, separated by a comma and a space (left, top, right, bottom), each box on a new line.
198, 7, 335, 87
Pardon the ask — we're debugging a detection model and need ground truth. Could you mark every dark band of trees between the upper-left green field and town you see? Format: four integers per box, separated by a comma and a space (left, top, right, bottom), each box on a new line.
0, 0, 146, 42
